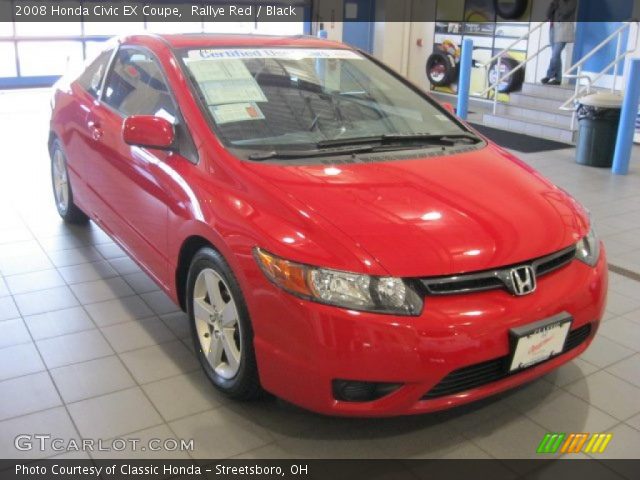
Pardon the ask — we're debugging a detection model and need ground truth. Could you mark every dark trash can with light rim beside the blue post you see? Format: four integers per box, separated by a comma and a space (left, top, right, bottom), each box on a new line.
576, 92, 622, 168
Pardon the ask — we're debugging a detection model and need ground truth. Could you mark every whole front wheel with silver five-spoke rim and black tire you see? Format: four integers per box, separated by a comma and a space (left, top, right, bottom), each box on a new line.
187, 248, 261, 400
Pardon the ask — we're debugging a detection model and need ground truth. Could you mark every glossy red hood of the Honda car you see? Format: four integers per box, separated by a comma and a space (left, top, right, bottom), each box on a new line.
245, 145, 588, 276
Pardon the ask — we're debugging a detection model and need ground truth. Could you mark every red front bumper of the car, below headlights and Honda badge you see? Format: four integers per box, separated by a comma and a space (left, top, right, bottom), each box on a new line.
247, 249, 607, 416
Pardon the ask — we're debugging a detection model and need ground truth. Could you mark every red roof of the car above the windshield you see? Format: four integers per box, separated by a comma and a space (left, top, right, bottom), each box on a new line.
122, 33, 351, 49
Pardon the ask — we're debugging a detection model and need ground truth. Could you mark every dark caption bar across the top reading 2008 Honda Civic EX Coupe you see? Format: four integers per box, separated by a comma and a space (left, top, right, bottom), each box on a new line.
0, 0, 640, 23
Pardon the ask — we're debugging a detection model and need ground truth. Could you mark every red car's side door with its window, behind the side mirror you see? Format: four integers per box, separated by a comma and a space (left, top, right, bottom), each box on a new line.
88, 47, 186, 284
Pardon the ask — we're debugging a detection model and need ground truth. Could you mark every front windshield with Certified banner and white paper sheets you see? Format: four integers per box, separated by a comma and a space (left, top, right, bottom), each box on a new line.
180, 48, 469, 150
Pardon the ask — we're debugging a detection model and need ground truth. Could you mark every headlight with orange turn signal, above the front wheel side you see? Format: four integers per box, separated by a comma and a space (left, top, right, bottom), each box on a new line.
254, 248, 422, 315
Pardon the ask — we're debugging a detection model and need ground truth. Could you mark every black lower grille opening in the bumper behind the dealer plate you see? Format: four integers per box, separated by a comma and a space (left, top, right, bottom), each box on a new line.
422, 323, 591, 400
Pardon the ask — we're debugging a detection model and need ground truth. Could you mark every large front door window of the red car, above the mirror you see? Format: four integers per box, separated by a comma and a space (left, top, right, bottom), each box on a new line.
103, 48, 176, 123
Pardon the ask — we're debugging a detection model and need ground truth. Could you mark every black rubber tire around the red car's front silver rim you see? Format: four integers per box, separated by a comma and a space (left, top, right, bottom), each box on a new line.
186, 247, 264, 400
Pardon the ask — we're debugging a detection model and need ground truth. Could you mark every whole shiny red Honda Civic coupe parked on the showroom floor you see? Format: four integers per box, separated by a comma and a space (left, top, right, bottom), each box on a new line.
49, 35, 607, 416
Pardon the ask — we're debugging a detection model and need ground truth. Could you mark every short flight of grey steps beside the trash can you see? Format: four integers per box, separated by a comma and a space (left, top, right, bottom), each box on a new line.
482, 83, 576, 143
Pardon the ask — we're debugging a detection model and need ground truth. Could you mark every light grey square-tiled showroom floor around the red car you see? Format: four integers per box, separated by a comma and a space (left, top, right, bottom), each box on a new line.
0, 91, 640, 458
